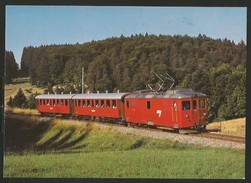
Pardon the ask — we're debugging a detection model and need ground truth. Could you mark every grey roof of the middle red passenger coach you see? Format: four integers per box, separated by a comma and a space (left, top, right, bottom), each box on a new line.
72, 93, 129, 99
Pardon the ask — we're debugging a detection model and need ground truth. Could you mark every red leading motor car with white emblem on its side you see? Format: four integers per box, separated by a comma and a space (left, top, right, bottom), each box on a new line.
125, 89, 208, 129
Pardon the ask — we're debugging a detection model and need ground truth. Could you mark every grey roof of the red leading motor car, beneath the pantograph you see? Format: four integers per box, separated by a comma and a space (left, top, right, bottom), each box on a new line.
126, 88, 206, 98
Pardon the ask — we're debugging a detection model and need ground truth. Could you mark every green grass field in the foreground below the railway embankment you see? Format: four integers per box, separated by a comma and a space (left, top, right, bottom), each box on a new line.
3, 117, 245, 179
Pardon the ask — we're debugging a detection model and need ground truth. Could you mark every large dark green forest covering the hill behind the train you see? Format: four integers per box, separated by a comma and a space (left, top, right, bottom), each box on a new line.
5, 33, 247, 121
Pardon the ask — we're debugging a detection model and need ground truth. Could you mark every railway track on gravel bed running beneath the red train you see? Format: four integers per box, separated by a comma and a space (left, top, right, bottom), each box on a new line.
5, 112, 246, 144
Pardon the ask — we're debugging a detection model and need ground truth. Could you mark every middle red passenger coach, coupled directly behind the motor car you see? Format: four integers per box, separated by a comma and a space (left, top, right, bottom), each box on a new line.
72, 93, 129, 120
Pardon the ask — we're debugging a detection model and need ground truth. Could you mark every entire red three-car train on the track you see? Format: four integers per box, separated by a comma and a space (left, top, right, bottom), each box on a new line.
36, 89, 208, 130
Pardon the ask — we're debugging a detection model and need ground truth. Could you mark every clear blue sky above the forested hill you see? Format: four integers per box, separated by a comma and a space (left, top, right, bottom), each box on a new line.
5, 5, 247, 64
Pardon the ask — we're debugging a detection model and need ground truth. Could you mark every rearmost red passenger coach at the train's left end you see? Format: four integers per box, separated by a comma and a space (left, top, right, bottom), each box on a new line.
35, 94, 74, 115
